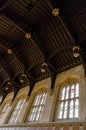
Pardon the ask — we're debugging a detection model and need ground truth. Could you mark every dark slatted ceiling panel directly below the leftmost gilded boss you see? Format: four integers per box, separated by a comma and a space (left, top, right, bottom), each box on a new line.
1, 54, 24, 79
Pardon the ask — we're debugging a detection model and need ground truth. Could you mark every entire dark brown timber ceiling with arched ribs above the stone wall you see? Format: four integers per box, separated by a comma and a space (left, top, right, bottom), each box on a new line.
0, 0, 86, 100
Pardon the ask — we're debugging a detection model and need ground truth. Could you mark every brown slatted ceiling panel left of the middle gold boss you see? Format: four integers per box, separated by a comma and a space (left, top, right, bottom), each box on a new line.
0, 15, 25, 40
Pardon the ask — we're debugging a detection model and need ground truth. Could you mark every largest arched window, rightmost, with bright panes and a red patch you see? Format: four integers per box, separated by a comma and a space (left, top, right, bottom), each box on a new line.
55, 82, 79, 119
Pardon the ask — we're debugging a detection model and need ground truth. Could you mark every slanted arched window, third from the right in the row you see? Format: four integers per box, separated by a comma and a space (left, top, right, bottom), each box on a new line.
8, 96, 26, 123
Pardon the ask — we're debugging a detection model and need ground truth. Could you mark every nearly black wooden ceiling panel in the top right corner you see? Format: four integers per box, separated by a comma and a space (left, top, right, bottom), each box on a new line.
61, 0, 86, 42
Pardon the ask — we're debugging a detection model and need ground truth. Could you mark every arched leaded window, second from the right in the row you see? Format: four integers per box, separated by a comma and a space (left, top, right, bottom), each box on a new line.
27, 91, 47, 121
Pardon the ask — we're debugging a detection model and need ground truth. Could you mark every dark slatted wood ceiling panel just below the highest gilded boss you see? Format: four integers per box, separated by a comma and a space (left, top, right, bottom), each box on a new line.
37, 17, 74, 59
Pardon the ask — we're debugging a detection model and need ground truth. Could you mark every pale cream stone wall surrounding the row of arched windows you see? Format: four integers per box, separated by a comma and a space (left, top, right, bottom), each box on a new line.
0, 65, 86, 123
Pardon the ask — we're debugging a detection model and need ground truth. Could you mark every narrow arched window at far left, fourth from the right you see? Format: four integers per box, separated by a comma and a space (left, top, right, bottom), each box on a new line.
0, 102, 10, 123
